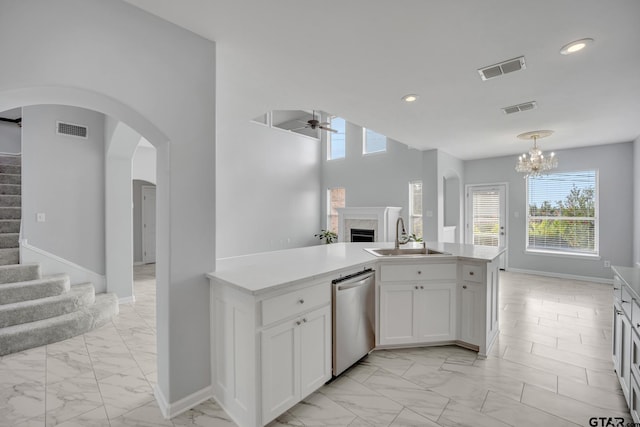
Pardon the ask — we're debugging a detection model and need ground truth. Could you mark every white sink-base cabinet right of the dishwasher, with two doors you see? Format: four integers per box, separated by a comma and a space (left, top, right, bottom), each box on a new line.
376, 262, 457, 346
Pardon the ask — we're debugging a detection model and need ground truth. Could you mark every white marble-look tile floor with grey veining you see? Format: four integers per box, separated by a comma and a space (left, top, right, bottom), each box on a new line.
0, 265, 631, 427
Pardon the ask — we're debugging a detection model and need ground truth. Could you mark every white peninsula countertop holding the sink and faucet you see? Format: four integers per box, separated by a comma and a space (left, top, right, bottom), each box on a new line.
207, 242, 504, 294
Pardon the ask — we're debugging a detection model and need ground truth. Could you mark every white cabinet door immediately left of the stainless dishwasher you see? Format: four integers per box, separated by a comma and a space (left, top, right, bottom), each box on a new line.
300, 306, 332, 399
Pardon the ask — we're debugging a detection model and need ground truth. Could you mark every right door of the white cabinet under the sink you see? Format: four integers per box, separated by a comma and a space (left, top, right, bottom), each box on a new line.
414, 283, 457, 343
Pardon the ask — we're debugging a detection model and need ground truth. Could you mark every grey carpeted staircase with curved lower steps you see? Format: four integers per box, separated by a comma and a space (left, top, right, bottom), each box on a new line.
0, 156, 119, 356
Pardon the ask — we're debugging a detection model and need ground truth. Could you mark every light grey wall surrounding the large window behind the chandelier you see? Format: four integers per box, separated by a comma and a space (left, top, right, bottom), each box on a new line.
465, 143, 634, 278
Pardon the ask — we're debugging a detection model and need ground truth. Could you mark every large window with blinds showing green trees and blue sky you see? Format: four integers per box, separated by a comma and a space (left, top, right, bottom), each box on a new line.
527, 170, 598, 255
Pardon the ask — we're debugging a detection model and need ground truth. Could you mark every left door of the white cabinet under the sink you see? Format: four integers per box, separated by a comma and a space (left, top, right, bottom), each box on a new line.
379, 284, 418, 345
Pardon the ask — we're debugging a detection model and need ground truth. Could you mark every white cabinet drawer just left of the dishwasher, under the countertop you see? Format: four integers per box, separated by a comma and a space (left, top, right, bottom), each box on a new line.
262, 282, 331, 325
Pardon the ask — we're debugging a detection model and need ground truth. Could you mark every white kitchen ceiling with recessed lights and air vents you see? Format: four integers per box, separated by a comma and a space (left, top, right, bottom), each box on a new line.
121, 0, 640, 160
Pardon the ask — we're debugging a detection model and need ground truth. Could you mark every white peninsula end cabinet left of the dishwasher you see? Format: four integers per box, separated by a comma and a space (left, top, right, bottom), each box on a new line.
211, 277, 331, 427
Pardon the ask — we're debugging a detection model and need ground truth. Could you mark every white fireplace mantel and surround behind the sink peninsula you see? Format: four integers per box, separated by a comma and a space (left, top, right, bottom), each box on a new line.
337, 206, 402, 242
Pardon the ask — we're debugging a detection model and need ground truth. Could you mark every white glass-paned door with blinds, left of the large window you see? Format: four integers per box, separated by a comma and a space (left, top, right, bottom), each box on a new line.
466, 184, 507, 270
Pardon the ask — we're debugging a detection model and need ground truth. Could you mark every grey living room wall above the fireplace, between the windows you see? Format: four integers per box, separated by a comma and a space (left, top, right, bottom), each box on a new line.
316, 122, 423, 234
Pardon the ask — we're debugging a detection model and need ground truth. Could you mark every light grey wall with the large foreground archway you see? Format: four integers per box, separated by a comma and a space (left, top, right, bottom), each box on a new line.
0, 0, 216, 413
